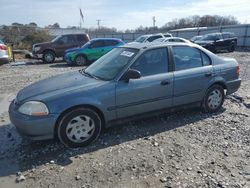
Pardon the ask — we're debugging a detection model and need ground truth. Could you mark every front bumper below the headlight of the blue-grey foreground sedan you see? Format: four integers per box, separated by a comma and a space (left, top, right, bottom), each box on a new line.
9, 101, 59, 140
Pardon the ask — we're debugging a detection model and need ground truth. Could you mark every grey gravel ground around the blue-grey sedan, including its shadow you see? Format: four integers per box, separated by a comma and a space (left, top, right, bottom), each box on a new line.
0, 51, 250, 188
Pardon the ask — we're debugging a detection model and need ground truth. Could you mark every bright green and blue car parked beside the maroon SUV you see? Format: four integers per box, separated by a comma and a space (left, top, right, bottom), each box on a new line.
64, 38, 125, 66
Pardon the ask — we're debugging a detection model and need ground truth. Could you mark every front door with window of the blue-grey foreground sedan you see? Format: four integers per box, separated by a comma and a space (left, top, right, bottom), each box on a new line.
116, 48, 173, 118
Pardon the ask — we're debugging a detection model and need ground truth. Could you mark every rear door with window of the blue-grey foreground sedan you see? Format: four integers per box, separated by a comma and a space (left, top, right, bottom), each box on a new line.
172, 46, 213, 106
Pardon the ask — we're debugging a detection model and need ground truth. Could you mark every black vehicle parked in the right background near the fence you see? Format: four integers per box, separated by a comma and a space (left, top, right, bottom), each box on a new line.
194, 32, 237, 52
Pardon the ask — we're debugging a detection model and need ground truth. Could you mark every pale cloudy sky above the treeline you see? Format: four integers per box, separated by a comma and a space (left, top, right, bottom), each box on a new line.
0, 0, 250, 30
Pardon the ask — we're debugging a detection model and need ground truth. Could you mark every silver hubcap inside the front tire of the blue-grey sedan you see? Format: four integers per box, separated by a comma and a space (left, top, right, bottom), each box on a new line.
66, 115, 95, 143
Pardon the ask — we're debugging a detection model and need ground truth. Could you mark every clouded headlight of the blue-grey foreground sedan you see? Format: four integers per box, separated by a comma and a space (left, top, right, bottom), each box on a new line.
18, 101, 49, 116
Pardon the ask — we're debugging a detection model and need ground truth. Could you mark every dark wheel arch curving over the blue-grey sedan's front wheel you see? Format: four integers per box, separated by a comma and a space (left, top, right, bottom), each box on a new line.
54, 104, 106, 138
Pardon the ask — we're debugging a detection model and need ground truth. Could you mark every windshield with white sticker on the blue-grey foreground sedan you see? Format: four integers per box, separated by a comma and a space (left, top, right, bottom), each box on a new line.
84, 48, 139, 80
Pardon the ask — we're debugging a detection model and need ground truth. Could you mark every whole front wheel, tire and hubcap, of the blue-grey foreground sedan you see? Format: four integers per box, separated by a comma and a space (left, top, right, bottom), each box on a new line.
57, 108, 102, 148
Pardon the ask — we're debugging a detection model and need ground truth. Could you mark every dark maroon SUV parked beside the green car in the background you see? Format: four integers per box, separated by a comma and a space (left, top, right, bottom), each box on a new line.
32, 34, 90, 63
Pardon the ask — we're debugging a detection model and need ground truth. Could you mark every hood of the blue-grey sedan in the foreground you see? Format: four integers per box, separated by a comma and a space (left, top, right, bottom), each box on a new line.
16, 71, 103, 103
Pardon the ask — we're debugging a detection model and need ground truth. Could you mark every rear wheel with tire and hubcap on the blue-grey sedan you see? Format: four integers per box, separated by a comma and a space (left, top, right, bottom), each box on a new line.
202, 84, 225, 113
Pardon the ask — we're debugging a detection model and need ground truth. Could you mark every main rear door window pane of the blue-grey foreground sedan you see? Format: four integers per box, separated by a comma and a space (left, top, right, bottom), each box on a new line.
173, 46, 202, 71
